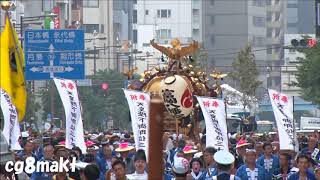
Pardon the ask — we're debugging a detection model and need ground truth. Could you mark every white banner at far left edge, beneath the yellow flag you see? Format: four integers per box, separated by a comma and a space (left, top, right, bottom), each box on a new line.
0, 88, 21, 150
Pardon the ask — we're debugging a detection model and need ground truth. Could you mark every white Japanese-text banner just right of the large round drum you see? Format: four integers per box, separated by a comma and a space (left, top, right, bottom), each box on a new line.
197, 96, 229, 150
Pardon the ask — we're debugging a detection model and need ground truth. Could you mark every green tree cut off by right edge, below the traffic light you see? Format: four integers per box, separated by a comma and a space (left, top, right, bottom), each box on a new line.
296, 44, 320, 106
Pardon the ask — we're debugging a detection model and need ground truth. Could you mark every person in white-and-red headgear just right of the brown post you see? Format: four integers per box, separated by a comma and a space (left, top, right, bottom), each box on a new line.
172, 156, 189, 180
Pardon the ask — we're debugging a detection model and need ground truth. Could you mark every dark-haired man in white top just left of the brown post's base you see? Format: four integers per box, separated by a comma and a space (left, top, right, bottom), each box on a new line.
127, 149, 148, 180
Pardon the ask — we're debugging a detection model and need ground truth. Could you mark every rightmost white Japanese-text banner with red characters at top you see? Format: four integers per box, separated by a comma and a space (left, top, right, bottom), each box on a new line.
268, 89, 298, 150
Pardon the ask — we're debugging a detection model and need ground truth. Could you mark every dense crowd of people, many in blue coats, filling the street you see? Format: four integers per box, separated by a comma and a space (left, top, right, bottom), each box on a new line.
1, 131, 320, 180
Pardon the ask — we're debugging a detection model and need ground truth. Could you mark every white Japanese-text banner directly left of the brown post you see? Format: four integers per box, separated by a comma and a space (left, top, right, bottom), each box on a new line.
124, 89, 150, 157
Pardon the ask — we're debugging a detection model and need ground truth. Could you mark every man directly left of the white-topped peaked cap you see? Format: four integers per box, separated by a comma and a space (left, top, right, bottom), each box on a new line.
203, 147, 217, 178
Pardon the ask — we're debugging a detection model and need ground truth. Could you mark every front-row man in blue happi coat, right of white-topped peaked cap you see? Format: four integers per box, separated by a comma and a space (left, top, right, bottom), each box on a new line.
236, 149, 270, 180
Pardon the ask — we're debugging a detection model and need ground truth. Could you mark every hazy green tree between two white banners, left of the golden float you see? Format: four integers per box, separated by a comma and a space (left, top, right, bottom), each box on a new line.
79, 70, 129, 128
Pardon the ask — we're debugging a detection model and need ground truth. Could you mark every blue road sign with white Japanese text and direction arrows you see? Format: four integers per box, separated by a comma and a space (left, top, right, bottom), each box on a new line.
24, 29, 85, 80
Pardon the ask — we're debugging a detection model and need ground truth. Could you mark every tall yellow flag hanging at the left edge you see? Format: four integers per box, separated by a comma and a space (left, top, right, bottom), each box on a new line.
0, 16, 27, 121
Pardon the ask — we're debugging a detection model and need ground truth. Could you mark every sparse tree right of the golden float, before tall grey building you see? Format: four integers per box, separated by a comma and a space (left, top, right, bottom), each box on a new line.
230, 44, 262, 108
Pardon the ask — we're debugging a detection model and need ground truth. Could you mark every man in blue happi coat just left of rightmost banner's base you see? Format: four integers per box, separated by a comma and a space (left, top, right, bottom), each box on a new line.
257, 142, 280, 179
